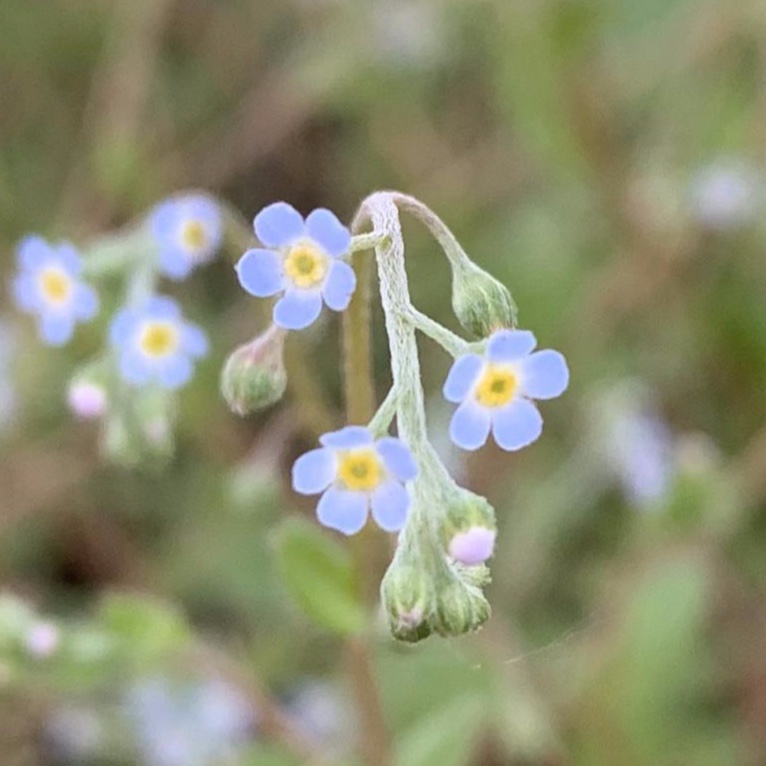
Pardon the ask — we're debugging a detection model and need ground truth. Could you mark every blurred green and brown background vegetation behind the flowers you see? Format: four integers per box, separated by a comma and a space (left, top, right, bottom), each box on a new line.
0, 0, 766, 766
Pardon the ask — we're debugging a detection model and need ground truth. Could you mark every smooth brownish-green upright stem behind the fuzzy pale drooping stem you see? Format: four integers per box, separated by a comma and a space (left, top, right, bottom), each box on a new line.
343, 248, 392, 766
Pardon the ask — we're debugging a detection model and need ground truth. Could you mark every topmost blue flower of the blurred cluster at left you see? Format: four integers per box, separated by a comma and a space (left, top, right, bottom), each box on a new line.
149, 194, 223, 279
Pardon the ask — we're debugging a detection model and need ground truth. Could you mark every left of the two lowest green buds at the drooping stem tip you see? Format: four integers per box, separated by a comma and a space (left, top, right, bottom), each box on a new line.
380, 560, 433, 643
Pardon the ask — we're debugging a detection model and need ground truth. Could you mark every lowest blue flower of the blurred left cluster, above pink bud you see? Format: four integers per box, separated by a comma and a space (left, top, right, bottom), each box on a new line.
109, 296, 207, 388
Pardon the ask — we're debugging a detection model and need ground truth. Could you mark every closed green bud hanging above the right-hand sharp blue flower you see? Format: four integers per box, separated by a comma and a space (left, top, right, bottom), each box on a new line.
452, 261, 516, 338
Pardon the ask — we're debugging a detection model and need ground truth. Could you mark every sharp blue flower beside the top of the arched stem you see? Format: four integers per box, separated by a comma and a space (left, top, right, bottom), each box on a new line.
237, 202, 356, 330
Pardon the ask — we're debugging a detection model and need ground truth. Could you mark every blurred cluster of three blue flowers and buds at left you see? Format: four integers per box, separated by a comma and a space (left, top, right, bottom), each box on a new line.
11, 194, 224, 462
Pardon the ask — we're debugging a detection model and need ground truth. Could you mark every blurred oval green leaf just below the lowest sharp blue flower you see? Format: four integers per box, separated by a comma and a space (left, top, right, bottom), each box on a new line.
275, 519, 365, 635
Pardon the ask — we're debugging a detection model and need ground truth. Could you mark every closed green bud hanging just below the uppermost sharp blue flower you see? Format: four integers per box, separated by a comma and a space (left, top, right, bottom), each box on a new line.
221, 325, 287, 416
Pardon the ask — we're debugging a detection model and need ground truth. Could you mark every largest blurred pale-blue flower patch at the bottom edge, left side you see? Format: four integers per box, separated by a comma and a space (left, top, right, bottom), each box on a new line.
126, 678, 255, 766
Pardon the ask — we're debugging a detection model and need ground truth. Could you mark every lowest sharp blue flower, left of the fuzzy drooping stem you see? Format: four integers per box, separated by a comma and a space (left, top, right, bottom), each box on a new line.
293, 426, 418, 535
